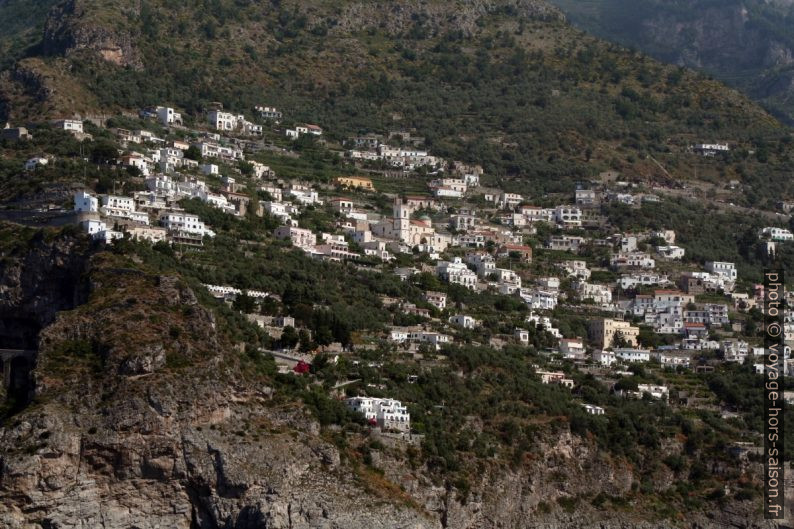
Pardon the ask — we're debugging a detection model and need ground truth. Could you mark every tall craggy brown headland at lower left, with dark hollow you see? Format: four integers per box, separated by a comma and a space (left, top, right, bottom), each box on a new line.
0, 238, 439, 529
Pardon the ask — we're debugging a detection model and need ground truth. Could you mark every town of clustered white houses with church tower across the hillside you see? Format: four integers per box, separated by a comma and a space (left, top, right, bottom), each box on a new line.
3, 105, 794, 433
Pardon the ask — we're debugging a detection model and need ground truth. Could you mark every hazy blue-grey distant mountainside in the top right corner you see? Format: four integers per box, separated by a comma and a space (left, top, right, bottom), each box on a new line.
551, 0, 794, 121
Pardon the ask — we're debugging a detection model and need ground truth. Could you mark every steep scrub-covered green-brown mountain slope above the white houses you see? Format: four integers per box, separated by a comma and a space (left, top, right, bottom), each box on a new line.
0, 0, 789, 202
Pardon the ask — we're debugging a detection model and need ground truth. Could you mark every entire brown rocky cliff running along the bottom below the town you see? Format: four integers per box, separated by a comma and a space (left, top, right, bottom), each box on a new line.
0, 232, 772, 529
